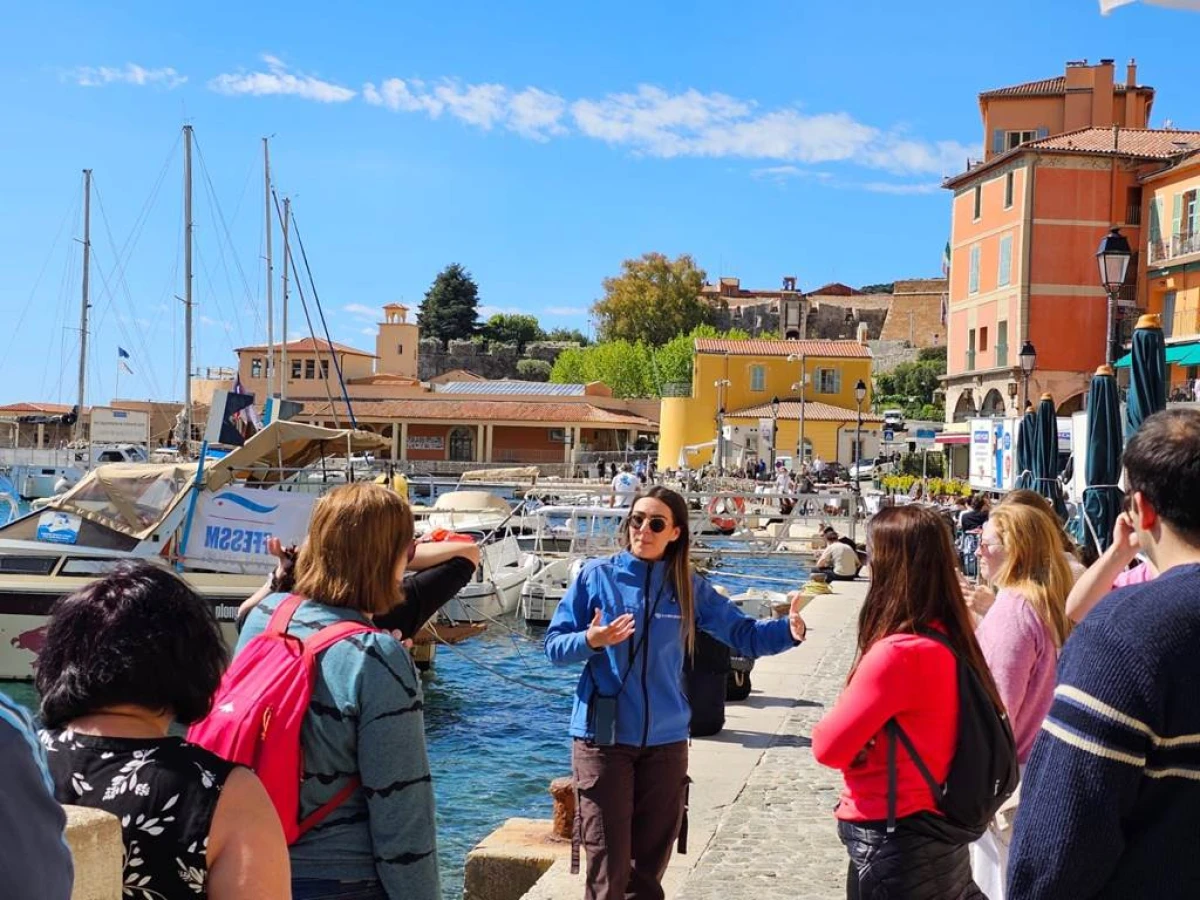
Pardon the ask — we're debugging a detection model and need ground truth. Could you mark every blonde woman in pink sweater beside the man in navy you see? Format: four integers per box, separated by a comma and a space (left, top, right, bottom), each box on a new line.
971, 504, 1072, 900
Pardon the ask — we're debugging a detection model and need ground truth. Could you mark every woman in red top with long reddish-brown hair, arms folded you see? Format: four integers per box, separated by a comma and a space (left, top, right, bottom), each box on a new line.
812, 505, 1003, 900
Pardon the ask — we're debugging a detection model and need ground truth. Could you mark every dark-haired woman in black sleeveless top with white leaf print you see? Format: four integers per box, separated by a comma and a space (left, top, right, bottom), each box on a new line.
36, 563, 290, 900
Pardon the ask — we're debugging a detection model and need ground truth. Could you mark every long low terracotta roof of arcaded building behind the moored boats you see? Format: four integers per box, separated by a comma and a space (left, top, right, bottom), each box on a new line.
302, 396, 658, 430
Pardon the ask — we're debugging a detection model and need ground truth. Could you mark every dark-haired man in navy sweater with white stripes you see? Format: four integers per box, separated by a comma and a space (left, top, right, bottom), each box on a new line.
1008, 409, 1200, 900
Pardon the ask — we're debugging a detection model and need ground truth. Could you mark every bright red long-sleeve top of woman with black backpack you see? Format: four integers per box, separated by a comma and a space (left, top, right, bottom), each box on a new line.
812, 634, 959, 822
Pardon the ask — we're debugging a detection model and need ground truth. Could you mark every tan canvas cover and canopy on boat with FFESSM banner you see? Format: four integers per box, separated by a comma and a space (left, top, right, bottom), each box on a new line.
46, 421, 390, 540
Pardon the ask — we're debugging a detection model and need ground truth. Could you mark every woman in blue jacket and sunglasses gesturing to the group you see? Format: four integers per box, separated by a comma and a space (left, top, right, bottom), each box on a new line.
546, 487, 805, 900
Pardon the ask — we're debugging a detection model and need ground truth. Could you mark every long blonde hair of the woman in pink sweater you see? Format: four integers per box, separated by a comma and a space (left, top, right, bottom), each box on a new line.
988, 503, 1073, 648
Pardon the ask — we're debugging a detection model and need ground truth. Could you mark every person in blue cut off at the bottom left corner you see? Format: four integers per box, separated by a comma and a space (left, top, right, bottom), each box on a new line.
0, 694, 74, 900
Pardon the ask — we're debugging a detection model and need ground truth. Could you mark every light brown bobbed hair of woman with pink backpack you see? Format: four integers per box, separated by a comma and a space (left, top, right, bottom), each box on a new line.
295, 482, 413, 614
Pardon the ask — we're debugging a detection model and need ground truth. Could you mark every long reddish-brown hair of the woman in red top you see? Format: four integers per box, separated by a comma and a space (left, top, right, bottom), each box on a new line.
850, 504, 1004, 712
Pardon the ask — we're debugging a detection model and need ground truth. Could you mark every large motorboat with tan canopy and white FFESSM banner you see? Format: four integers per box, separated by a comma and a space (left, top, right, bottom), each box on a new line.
0, 421, 398, 679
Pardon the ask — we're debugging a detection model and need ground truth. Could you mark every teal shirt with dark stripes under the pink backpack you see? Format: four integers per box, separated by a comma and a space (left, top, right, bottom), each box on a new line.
238, 594, 442, 900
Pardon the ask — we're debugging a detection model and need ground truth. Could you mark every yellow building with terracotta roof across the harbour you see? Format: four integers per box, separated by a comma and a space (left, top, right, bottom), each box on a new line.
659, 338, 882, 468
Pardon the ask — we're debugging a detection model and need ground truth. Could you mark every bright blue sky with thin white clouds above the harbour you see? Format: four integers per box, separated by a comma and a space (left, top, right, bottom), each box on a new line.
0, 0, 1200, 402
